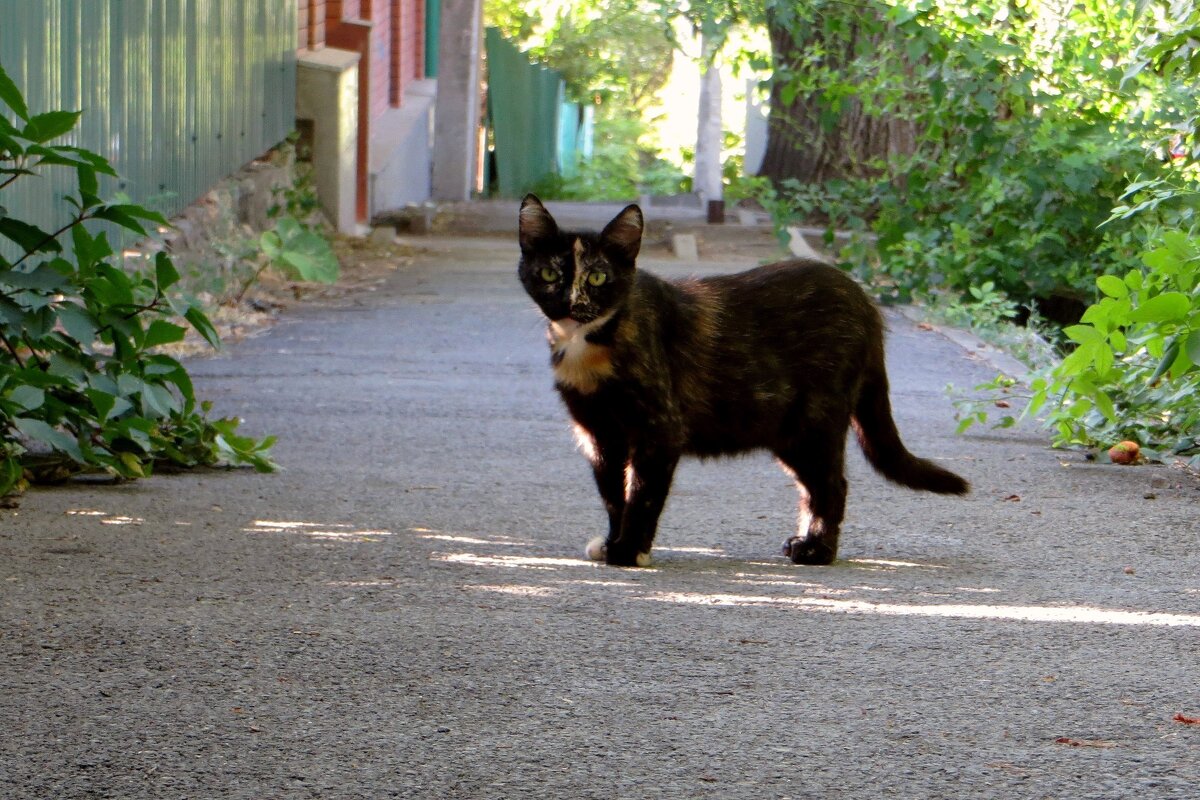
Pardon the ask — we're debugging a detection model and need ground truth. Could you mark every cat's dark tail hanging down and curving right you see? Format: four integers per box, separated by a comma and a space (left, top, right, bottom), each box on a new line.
854, 371, 971, 494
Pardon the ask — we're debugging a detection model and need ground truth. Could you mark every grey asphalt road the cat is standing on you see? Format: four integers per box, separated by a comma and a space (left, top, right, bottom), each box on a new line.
0, 220, 1200, 800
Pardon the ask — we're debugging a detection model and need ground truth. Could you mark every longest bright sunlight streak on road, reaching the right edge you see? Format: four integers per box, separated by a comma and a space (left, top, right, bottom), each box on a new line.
643, 591, 1200, 627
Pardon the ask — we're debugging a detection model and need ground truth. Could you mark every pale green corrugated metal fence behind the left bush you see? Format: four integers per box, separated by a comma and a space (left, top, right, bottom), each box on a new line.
0, 0, 296, 248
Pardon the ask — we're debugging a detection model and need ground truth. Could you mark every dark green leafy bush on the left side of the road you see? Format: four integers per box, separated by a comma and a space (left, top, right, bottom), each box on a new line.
0, 70, 274, 495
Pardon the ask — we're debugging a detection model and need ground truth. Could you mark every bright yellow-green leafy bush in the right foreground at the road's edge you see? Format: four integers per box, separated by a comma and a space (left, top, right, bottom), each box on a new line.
945, 4, 1200, 467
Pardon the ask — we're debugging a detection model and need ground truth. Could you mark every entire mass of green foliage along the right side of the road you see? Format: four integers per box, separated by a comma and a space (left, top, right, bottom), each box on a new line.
760, 0, 1200, 455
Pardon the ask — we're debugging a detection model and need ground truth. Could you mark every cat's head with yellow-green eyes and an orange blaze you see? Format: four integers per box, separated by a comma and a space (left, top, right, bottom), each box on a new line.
518, 194, 643, 323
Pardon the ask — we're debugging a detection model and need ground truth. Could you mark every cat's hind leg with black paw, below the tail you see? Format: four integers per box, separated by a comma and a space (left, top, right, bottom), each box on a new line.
775, 428, 846, 564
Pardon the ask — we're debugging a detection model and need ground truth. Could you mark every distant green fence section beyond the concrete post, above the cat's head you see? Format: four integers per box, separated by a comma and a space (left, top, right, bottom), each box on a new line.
485, 28, 592, 197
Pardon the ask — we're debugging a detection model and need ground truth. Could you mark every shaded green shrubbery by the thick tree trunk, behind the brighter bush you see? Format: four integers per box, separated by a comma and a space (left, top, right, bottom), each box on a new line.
768, 0, 1186, 302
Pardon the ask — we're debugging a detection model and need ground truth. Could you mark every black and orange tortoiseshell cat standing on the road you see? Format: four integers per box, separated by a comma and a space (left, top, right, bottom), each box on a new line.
518, 194, 968, 566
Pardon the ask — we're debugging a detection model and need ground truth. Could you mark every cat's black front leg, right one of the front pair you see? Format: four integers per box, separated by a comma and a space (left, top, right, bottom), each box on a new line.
605, 447, 679, 566
